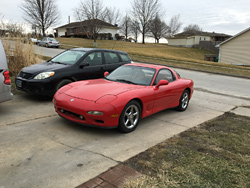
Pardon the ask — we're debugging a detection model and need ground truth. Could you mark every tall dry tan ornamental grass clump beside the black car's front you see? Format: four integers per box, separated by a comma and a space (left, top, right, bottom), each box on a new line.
2, 38, 39, 76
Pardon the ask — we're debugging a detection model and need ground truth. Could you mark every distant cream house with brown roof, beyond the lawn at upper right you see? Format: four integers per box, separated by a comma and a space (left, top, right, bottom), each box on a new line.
167, 31, 231, 51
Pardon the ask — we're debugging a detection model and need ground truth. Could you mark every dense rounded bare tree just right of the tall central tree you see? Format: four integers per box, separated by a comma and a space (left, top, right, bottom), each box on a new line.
149, 14, 168, 43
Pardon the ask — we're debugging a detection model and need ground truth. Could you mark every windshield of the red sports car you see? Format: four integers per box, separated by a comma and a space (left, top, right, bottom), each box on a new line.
106, 65, 156, 86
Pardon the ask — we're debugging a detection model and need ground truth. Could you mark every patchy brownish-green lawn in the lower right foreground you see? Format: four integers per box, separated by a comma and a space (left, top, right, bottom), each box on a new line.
124, 113, 250, 188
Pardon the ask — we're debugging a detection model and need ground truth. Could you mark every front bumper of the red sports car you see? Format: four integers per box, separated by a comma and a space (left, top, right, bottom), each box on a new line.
53, 92, 119, 128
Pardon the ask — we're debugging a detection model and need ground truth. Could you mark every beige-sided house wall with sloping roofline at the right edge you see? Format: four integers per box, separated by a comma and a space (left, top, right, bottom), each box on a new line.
218, 27, 250, 66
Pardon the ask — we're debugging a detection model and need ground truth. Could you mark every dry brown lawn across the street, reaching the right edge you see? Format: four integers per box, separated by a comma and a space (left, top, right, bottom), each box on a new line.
58, 38, 250, 78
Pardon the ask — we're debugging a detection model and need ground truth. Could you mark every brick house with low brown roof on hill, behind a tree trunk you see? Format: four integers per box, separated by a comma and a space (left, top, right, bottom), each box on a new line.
55, 20, 119, 39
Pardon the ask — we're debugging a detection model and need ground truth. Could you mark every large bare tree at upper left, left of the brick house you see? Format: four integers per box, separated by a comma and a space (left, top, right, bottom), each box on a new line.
20, 0, 59, 36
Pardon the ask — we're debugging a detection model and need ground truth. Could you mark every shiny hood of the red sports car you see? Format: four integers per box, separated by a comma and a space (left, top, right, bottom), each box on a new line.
62, 79, 144, 101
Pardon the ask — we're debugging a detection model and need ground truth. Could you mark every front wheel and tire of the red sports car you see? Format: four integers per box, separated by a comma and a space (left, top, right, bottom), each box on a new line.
118, 100, 141, 133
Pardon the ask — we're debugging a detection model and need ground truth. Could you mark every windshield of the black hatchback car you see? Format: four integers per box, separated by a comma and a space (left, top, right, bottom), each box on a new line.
51, 50, 86, 65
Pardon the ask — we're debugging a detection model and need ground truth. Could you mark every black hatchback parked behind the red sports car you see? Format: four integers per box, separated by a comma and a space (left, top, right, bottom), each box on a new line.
16, 48, 131, 96
